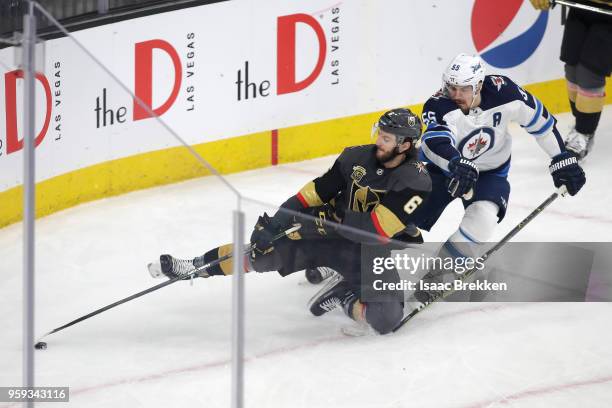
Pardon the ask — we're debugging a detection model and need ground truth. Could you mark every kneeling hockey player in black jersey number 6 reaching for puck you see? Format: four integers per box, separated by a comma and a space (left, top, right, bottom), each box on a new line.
149, 109, 431, 334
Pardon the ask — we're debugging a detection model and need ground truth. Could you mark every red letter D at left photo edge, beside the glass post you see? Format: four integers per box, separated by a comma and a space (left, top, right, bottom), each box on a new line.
4, 70, 51, 154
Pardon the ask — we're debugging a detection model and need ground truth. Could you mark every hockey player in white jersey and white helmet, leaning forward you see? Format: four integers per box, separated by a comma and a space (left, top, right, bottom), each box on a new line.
418, 54, 585, 302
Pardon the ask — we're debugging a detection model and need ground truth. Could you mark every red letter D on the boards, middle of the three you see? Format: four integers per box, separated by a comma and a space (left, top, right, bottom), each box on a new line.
134, 40, 183, 120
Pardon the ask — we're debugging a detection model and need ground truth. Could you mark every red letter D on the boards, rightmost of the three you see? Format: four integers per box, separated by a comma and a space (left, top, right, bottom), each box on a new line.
276, 14, 327, 95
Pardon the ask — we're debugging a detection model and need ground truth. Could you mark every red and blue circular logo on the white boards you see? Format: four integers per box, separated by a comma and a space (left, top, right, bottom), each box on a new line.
472, 0, 548, 68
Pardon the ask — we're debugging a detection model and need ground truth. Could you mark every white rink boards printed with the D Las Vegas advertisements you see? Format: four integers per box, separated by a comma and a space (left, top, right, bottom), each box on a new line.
0, 0, 559, 198
